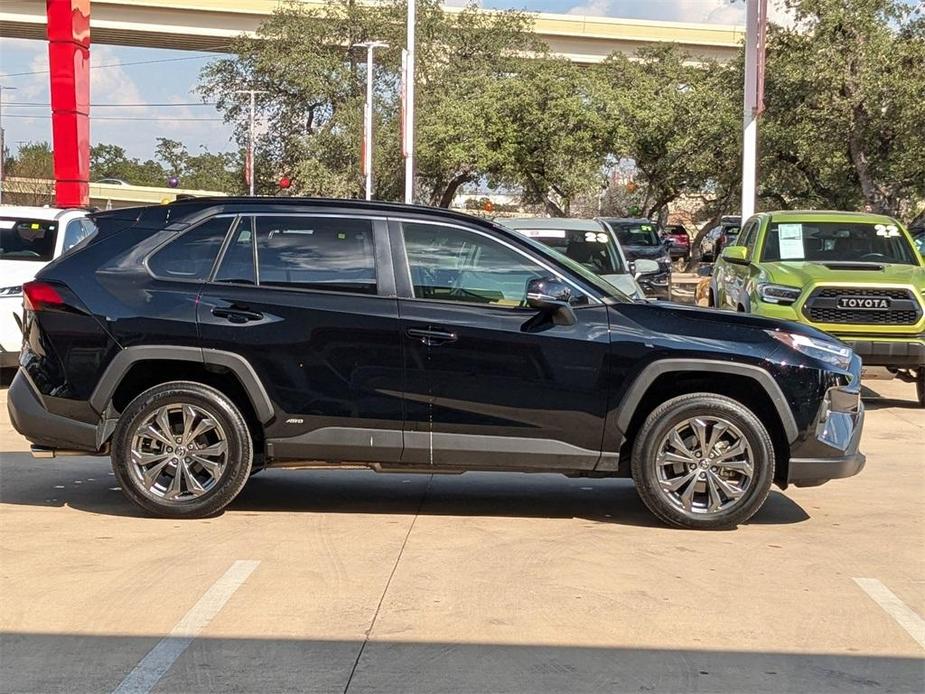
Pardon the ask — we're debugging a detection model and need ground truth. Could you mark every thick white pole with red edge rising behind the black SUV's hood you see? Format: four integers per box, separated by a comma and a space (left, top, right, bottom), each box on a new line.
742, 0, 768, 224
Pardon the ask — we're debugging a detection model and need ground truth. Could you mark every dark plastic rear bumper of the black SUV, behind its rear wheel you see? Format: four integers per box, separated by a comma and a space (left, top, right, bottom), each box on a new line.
6, 369, 99, 454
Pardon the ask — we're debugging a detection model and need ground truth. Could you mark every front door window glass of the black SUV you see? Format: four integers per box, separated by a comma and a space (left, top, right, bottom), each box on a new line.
403, 224, 551, 307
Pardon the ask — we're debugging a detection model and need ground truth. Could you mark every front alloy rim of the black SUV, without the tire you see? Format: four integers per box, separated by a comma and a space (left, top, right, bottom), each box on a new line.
655, 416, 754, 516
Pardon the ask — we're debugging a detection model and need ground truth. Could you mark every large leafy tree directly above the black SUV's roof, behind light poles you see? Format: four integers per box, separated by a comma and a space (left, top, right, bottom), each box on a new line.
200, 0, 560, 206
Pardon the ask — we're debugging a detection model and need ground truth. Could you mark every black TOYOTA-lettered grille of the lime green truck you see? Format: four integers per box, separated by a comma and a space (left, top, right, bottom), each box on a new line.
803, 287, 922, 325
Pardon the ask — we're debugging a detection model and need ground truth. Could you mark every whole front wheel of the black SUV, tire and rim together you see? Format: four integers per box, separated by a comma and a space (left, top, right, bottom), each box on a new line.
631, 393, 774, 530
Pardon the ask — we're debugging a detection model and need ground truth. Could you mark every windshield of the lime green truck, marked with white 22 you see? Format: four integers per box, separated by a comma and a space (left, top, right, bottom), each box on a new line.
762, 222, 917, 265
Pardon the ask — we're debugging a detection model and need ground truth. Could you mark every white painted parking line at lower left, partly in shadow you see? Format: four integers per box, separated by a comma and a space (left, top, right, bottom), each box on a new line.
113, 559, 260, 694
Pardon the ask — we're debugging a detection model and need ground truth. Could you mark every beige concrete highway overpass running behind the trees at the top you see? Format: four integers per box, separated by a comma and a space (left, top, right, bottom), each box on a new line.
0, 0, 745, 63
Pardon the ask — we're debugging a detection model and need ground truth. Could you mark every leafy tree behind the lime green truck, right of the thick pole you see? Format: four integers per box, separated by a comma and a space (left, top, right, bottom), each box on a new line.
760, 0, 925, 216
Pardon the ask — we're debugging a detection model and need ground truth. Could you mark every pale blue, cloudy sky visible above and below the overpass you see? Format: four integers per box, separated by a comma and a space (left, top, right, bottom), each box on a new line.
0, 0, 756, 158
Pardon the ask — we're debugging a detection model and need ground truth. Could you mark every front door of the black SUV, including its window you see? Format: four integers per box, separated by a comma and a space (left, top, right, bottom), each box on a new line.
399, 223, 609, 469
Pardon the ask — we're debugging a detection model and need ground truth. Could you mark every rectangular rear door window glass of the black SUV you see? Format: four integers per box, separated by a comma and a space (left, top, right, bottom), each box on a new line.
255, 215, 376, 294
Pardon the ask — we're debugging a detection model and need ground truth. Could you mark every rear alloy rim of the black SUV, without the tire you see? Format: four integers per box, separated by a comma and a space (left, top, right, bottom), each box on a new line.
129, 403, 228, 503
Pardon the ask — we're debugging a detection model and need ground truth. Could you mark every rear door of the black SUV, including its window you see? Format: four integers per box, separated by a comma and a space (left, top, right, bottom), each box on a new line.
198, 215, 403, 462
